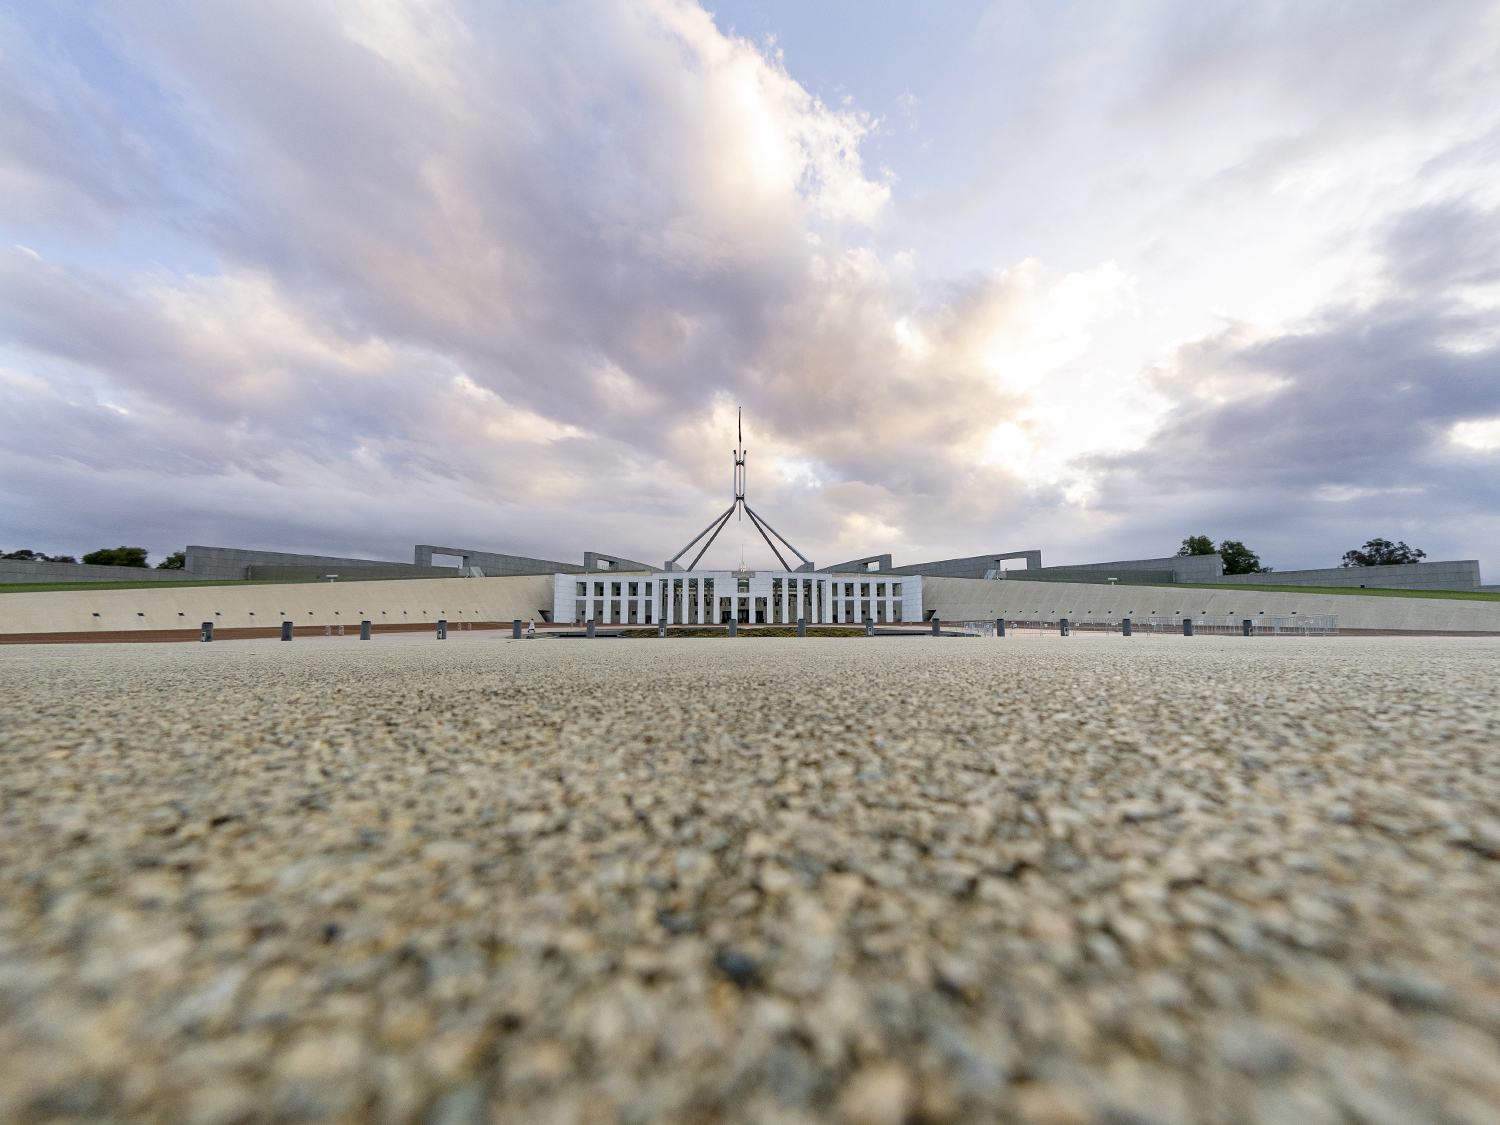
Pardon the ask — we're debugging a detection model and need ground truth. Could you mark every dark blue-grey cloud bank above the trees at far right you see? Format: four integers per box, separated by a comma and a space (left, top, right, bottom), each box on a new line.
1094, 203, 1500, 569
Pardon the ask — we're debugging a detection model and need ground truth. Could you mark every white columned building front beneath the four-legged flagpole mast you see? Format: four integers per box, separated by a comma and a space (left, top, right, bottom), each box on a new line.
552, 570, 923, 626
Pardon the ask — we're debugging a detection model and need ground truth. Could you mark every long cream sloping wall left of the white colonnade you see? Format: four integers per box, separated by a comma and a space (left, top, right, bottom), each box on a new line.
0, 575, 552, 633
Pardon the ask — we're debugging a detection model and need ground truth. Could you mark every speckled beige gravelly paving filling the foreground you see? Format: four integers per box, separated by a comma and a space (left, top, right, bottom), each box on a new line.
0, 635, 1500, 1125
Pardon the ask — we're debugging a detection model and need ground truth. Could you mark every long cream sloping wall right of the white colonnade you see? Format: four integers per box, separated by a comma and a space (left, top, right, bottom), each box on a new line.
918, 578, 1500, 632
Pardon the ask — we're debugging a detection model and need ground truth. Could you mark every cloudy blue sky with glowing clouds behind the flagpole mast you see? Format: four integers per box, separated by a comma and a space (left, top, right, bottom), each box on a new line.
0, 0, 1500, 582
